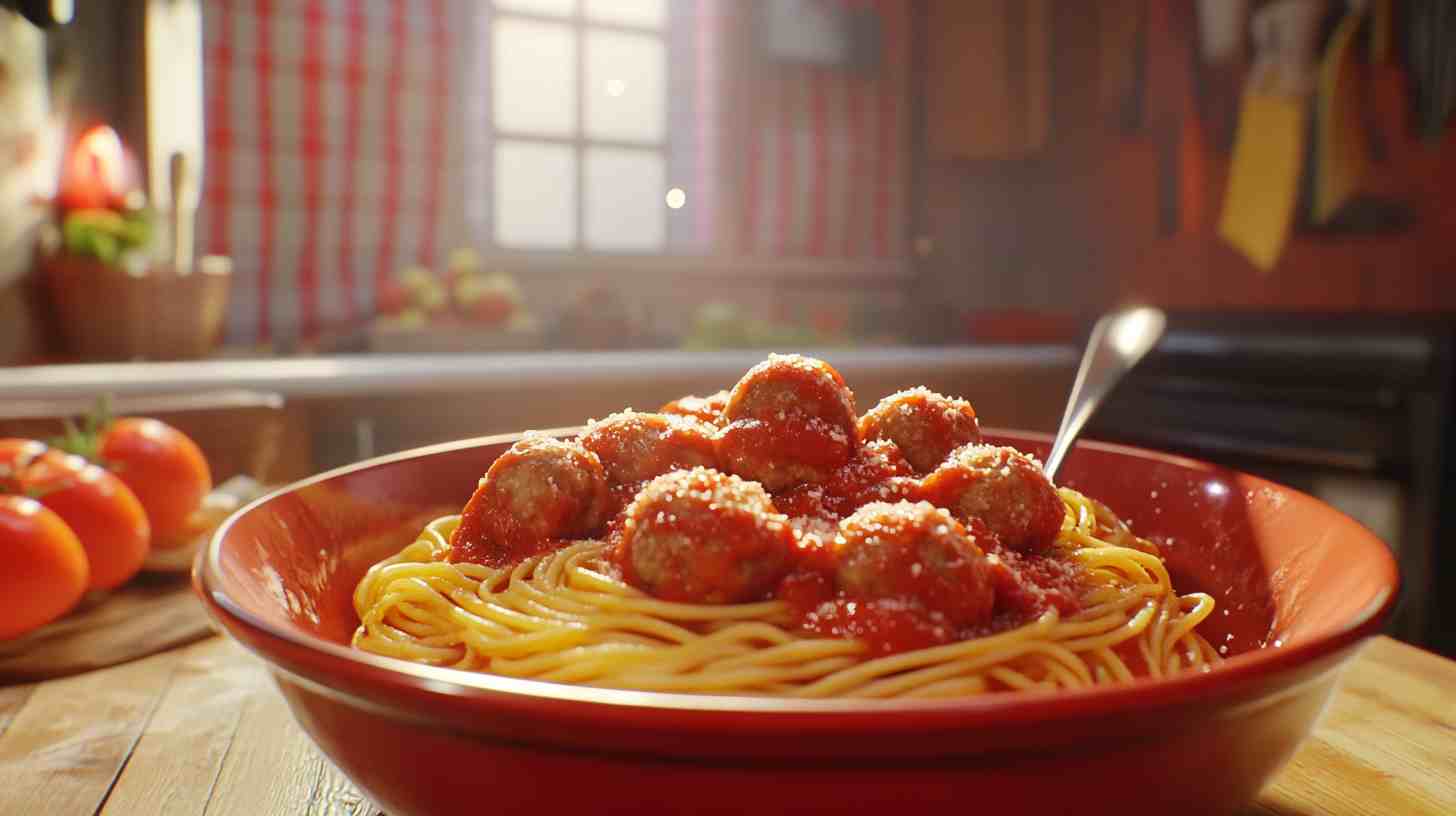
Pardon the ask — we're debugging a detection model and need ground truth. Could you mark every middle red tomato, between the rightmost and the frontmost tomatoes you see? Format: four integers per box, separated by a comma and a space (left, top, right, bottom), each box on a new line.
19, 450, 151, 589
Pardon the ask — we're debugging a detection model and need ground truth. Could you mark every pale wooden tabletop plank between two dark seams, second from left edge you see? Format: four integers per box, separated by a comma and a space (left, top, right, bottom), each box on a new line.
102, 638, 272, 816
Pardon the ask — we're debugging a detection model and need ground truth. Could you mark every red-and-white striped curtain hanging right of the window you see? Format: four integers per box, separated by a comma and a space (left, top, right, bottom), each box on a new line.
668, 0, 910, 261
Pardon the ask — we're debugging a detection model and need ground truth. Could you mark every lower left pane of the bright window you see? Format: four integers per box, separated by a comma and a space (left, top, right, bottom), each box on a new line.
495, 141, 577, 249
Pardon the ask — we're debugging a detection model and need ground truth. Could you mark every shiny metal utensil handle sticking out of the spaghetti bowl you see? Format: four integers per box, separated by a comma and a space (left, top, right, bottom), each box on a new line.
1045, 306, 1168, 479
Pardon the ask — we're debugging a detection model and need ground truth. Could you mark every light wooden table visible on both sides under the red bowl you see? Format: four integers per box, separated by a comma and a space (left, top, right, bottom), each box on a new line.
0, 637, 1456, 816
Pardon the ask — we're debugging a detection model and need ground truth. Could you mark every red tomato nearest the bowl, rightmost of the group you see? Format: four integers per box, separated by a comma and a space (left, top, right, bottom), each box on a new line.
96, 417, 213, 549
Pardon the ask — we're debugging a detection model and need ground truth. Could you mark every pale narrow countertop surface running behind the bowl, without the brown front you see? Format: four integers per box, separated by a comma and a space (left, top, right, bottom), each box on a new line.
0, 345, 1077, 401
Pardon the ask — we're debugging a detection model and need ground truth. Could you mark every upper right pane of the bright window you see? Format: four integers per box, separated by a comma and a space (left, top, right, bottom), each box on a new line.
587, 31, 667, 143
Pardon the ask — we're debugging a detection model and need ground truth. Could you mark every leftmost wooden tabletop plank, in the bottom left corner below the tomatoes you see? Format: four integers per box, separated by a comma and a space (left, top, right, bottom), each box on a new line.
0, 651, 178, 813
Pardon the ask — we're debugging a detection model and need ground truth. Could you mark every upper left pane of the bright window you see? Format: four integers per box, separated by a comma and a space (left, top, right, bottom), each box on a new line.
491, 17, 577, 136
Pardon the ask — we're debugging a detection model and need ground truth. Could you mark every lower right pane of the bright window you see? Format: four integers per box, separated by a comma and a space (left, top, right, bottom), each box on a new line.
585, 147, 667, 251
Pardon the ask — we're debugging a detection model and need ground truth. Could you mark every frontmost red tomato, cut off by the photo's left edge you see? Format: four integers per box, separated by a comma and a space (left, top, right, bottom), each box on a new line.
0, 495, 89, 640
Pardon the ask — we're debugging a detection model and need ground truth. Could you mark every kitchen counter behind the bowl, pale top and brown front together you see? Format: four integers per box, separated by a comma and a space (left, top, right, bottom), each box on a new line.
0, 345, 1079, 479
